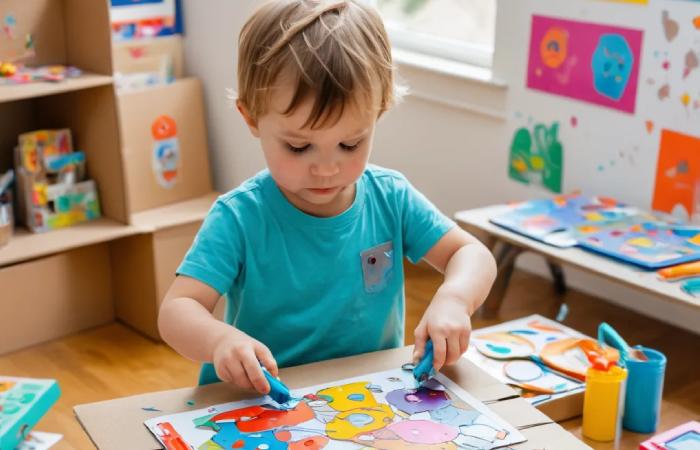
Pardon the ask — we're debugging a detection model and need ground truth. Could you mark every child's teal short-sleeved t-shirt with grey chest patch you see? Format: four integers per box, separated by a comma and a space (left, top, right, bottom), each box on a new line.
177, 166, 455, 384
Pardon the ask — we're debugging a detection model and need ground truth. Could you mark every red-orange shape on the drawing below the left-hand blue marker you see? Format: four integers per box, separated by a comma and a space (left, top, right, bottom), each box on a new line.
210, 402, 314, 433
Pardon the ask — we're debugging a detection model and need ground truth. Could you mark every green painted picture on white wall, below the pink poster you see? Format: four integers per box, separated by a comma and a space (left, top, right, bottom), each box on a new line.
508, 122, 564, 193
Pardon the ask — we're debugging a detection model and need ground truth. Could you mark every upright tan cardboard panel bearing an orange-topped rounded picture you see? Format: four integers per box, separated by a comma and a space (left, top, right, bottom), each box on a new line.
117, 78, 212, 218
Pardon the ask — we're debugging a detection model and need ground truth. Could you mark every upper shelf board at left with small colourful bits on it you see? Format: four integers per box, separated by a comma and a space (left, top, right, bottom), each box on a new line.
0, 73, 112, 103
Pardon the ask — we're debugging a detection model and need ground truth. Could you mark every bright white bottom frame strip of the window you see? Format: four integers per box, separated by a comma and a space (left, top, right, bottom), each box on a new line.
365, 0, 494, 69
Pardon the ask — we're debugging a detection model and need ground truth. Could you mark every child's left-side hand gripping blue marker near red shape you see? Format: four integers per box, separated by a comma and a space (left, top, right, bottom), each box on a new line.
212, 330, 277, 394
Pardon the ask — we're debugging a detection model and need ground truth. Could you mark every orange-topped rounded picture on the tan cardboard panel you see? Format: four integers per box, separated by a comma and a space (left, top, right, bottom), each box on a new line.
151, 115, 180, 189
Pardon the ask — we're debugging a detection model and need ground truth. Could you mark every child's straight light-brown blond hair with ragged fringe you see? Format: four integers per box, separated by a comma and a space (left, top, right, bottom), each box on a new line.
238, 0, 395, 128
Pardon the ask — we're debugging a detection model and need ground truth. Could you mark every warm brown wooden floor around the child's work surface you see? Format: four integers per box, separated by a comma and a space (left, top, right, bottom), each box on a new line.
0, 267, 700, 450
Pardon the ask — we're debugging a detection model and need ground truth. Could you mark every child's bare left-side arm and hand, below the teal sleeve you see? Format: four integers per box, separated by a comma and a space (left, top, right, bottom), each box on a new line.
158, 276, 277, 394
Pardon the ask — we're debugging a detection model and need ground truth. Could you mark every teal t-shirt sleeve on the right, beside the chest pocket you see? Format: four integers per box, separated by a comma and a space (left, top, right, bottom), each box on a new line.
395, 172, 456, 264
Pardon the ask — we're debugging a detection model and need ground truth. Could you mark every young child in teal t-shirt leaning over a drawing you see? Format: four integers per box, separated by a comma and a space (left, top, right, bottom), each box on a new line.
158, 0, 496, 393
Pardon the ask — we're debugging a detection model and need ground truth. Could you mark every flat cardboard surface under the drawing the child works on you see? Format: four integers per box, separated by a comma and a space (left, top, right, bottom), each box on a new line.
74, 347, 590, 450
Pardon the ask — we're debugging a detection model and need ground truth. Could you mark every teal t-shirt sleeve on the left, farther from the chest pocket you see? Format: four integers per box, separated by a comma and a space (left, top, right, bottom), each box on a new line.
177, 199, 244, 295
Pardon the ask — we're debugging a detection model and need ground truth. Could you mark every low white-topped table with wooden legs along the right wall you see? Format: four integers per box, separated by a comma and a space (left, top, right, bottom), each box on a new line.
455, 205, 700, 317
